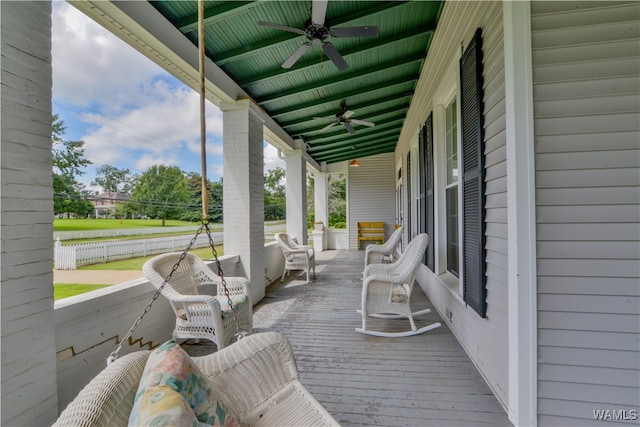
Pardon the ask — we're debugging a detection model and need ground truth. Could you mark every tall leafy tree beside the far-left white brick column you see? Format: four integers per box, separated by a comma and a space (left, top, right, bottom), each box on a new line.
51, 114, 93, 216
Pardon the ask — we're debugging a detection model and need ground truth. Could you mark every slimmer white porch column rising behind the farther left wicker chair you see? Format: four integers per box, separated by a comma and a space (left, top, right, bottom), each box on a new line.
284, 150, 308, 245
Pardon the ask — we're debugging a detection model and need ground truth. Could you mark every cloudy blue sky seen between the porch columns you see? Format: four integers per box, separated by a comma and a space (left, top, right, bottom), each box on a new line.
52, 0, 284, 190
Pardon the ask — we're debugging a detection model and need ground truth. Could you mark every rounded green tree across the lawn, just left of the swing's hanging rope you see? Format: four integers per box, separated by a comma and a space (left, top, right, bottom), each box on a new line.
129, 165, 189, 227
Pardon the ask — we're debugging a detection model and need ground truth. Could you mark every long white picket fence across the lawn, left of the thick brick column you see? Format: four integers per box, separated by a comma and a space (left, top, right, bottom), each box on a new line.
54, 233, 223, 270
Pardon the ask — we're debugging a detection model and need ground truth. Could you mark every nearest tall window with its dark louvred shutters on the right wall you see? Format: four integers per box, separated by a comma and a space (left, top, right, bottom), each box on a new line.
419, 29, 486, 317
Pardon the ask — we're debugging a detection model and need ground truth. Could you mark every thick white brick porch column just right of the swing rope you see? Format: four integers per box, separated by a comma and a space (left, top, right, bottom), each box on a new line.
221, 99, 266, 304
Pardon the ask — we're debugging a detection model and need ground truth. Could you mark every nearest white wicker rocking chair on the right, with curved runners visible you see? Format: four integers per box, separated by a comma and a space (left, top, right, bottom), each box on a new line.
356, 233, 441, 337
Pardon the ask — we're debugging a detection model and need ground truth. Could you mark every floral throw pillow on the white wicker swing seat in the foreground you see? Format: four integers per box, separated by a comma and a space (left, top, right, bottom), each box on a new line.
129, 341, 238, 427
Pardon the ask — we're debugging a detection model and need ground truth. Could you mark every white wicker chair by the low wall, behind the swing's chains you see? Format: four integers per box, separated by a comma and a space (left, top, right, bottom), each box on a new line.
142, 252, 253, 350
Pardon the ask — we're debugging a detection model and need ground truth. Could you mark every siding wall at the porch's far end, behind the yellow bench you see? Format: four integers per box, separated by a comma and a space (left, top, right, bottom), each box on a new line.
347, 153, 396, 249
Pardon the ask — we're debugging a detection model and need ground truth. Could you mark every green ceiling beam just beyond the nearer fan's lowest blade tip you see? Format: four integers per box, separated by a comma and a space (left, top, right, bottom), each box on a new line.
257, 52, 424, 105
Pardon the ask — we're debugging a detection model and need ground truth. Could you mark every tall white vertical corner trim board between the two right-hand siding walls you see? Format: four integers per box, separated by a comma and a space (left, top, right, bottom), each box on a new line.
503, 1, 538, 426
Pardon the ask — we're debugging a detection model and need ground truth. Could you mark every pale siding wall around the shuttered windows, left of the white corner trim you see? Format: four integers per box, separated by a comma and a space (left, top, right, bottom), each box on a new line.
396, 2, 509, 407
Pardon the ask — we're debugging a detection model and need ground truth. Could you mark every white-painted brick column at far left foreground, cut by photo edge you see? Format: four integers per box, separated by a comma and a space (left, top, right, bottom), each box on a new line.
0, 2, 58, 426
